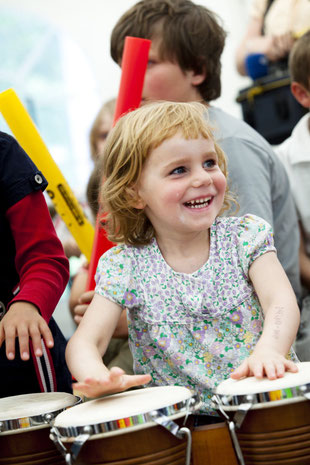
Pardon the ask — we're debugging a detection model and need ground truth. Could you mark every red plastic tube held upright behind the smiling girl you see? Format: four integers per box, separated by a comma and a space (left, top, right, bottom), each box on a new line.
87, 37, 151, 290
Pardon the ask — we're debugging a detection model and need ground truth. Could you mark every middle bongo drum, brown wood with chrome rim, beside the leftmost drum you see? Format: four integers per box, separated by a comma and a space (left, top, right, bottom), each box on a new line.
51, 386, 199, 465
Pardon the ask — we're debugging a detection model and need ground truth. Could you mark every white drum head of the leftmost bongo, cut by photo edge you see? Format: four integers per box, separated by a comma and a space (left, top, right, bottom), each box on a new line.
0, 392, 79, 421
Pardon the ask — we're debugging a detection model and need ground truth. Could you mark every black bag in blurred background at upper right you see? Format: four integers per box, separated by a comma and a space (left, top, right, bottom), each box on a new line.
237, 70, 307, 144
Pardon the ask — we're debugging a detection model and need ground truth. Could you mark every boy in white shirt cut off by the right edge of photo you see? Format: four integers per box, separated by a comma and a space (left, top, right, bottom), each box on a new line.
277, 30, 310, 360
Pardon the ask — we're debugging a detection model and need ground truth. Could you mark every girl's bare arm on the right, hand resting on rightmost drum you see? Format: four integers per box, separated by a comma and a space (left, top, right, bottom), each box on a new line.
232, 252, 300, 379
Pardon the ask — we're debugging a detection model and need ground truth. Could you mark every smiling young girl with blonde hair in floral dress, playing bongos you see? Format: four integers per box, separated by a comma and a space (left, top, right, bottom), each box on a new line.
67, 102, 299, 414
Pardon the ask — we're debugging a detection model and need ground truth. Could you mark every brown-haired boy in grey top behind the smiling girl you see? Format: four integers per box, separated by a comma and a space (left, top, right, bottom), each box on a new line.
111, 0, 300, 298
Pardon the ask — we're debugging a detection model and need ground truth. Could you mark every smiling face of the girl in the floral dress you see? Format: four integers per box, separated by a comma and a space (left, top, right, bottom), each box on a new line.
137, 133, 226, 237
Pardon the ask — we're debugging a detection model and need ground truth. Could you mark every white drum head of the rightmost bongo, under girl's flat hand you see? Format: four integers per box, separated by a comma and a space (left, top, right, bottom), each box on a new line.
215, 362, 310, 396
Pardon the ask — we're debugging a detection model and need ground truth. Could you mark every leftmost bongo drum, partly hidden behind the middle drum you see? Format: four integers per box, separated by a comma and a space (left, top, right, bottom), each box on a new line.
0, 392, 80, 465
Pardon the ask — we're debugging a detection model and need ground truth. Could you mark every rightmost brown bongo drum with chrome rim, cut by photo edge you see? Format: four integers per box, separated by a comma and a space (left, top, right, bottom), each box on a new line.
212, 362, 310, 465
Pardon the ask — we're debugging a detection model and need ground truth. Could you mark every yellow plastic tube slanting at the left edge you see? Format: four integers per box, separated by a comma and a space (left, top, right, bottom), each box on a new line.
0, 89, 95, 261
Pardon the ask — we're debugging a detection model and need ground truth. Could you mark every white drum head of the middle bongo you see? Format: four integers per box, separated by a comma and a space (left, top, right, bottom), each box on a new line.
54, 386, 193, 428
